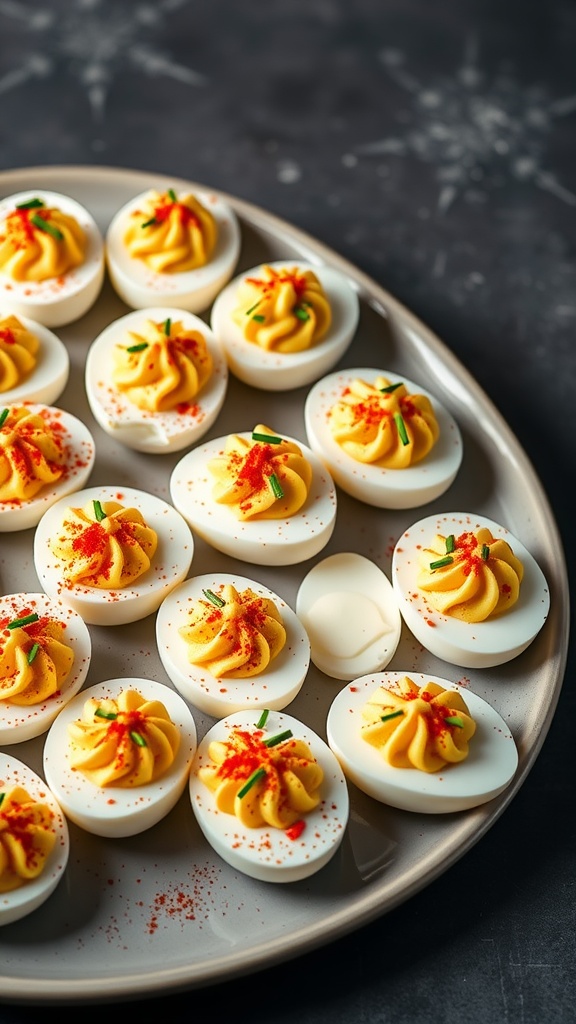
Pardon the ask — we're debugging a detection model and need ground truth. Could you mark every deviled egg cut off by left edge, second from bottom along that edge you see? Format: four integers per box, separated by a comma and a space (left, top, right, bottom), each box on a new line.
0, 594, 92, 745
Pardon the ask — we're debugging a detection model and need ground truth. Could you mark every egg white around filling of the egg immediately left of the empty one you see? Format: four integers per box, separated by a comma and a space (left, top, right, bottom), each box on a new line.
156, 573, 310, 718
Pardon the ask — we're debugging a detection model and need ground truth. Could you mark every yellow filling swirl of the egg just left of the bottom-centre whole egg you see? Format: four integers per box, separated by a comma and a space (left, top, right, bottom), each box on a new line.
68, 690, 180, 788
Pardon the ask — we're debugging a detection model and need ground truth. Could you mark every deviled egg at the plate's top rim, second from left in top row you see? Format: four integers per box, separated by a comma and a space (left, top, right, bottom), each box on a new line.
106, 188, 241, 313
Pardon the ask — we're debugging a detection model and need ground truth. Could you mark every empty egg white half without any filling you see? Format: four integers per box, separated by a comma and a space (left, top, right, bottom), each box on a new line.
296, 552, 402, 679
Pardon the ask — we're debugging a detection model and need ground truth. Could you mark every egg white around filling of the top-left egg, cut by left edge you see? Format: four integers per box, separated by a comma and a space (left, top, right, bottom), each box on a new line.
0, 189, 105, 327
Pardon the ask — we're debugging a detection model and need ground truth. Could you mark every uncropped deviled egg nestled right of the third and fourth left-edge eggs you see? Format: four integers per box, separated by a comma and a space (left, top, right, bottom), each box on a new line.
34, 486, 194, 626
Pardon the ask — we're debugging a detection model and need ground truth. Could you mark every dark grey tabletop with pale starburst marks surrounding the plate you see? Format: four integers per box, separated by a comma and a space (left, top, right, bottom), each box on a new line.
0, 0, 576, 1024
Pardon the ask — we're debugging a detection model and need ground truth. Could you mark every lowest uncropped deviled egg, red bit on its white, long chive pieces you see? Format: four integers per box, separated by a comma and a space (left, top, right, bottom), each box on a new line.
190, 711, 349, 883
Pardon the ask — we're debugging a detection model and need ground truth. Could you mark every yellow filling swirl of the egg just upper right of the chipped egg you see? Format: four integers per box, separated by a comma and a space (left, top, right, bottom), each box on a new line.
233, 265, 332, 353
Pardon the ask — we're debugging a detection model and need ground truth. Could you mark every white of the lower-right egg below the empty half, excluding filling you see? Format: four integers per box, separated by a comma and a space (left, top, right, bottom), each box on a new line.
326, 672, 518, 814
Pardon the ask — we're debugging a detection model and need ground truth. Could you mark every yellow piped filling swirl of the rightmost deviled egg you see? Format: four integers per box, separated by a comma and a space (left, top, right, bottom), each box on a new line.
416, 526, 524, 623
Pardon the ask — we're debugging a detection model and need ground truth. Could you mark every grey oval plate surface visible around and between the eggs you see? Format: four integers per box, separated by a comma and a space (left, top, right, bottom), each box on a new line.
0, 167, 569, 1002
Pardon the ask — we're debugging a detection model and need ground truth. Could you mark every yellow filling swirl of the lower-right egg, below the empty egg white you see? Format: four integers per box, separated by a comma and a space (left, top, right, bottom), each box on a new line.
361, 676, 476, 772
